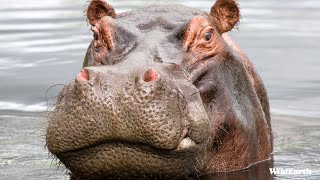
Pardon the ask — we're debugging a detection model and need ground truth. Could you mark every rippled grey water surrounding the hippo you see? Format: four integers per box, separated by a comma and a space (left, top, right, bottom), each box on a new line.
0, 0, 320, 179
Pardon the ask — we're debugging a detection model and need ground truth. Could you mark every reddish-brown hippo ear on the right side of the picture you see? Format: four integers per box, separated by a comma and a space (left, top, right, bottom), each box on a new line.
210, 0, 240, 34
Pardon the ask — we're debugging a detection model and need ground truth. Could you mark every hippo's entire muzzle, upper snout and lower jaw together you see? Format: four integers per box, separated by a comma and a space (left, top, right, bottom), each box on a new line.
47, 67, 210, 178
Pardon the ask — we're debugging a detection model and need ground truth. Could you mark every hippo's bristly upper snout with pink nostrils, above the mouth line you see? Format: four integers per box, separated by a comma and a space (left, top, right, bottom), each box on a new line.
47, 66, 209, 158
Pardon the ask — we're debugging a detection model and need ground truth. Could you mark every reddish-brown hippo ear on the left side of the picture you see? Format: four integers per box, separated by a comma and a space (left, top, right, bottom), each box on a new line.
87, 0, 116, 26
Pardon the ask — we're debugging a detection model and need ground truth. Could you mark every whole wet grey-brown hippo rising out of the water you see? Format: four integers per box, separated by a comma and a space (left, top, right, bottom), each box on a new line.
46, 0, 273, 179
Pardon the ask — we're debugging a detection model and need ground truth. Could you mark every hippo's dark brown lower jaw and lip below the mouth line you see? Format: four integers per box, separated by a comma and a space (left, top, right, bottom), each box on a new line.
56, 137, 205, 179
